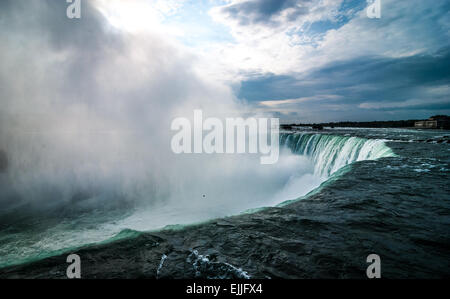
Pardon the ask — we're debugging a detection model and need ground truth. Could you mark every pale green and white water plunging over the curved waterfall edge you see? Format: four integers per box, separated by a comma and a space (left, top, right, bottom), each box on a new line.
0, 133, 394, 267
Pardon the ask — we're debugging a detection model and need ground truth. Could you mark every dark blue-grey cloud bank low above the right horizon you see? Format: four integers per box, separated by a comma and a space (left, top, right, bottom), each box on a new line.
239, 48, 450, 121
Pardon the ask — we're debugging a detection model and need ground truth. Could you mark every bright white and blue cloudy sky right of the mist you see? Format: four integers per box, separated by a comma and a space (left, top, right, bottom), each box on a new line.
78, 0, 450, 122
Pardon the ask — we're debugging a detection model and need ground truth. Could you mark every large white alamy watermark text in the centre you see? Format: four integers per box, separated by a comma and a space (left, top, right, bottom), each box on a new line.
171, 110, 280, 164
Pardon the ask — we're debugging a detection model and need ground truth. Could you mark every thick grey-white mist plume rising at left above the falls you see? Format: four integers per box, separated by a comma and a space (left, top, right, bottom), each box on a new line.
0, 0, 243, 211
